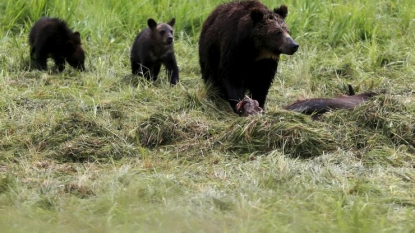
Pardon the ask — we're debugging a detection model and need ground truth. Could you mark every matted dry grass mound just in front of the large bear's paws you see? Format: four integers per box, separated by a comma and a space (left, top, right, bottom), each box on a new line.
221, 111, 336, 158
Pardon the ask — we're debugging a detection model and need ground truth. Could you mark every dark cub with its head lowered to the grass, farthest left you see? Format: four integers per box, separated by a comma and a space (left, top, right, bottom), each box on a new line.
29, 17, 85, 71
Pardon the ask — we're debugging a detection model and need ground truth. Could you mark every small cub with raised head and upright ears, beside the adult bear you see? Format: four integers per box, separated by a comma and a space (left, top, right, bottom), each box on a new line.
130, 18, 179, 85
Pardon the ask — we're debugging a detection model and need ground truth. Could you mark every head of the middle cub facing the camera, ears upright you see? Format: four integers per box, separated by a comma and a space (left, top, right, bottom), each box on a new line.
147, 18, 176, 45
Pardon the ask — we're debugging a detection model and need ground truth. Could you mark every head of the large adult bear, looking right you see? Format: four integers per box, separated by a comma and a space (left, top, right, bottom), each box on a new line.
251, 5, 299, 59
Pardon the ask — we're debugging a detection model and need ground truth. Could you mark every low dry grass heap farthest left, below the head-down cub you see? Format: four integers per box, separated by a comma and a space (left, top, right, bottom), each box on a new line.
39, 113, 136, 162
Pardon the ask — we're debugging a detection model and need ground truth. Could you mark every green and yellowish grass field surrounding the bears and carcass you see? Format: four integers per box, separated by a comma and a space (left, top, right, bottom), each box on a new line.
0, 0, 415, 233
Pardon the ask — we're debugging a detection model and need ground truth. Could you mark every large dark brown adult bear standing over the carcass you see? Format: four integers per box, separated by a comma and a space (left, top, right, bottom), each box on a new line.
199, 1, 299, 115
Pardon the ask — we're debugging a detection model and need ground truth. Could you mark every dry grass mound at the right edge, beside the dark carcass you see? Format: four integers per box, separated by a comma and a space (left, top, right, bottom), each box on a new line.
326, 96, 415, 150
